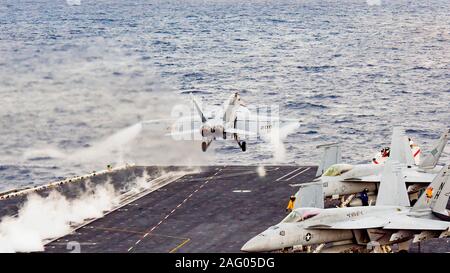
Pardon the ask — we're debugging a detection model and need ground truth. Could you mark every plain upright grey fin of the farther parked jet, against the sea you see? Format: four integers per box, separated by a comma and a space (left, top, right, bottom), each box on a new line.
389, 127, 415, 166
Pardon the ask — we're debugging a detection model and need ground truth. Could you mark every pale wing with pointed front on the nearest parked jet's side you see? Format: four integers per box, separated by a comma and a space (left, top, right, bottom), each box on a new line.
307, 216, 389, 229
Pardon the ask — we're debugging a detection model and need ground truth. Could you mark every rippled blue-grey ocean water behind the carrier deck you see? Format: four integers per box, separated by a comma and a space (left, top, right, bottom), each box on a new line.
0, 0, 450, 190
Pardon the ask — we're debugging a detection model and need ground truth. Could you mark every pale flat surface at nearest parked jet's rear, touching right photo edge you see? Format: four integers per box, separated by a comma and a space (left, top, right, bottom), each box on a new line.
383, 216, 450, 230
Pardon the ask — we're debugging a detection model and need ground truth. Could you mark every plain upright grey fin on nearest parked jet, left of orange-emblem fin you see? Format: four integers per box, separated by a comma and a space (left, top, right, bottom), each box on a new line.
376, 159, 410, 207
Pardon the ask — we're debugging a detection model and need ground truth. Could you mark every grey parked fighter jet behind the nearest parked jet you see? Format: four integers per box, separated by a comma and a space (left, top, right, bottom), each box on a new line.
299, 127, 449, 198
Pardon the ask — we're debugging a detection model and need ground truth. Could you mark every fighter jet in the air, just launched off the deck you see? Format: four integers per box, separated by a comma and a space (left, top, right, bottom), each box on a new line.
146, 92, 300, 152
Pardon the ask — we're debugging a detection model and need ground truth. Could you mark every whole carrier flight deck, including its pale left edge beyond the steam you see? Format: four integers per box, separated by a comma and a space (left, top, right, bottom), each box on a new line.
0, 165, 450, 253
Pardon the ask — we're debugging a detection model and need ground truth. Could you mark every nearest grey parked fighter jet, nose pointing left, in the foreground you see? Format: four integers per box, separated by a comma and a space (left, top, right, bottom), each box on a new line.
241, 160, 450, 252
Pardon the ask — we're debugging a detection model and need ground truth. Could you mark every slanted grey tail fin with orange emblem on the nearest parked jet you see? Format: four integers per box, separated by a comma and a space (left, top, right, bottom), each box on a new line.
411, 165, 450, 220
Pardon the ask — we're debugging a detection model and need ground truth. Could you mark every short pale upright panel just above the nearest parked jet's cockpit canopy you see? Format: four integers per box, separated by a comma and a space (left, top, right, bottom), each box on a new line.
294, 182, 324, 209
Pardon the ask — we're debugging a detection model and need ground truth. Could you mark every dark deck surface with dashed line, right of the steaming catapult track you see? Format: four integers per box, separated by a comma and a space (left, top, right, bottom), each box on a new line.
45, 166, 317, 253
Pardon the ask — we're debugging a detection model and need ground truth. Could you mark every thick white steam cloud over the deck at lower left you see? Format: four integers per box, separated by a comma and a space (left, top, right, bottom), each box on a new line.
0, 178, 127, 252
